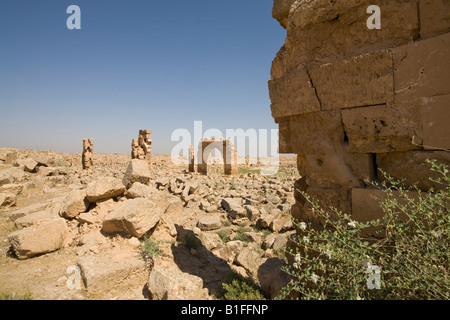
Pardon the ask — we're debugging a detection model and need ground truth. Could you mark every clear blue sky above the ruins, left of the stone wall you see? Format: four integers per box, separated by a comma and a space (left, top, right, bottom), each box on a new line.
0, 0, 285, 154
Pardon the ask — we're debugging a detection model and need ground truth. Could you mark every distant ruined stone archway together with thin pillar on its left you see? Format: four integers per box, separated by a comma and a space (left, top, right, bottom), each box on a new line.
195, 137, 238, 176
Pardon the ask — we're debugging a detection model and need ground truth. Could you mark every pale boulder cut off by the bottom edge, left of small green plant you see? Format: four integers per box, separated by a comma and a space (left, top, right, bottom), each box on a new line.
148, 265, 203, 300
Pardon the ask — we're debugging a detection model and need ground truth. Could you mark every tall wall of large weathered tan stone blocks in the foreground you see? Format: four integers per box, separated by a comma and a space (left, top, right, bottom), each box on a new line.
269, 0, 450, 220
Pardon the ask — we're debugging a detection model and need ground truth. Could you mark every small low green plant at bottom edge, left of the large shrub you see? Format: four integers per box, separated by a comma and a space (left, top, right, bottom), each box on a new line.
222, 272, 265, 300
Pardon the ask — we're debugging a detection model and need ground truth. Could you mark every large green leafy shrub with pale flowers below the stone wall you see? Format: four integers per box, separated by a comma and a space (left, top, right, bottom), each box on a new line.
278, 161, 450, 299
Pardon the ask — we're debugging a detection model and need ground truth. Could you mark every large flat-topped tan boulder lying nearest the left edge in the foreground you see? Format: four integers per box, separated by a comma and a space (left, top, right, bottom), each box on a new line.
8, 218, 67, 259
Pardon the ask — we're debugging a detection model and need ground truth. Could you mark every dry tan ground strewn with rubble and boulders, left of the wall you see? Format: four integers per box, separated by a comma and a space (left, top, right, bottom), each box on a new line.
0, 149, 296, 299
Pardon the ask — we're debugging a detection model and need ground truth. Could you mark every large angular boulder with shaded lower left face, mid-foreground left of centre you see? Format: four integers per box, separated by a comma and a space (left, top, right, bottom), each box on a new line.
103, 198, 164, 238
